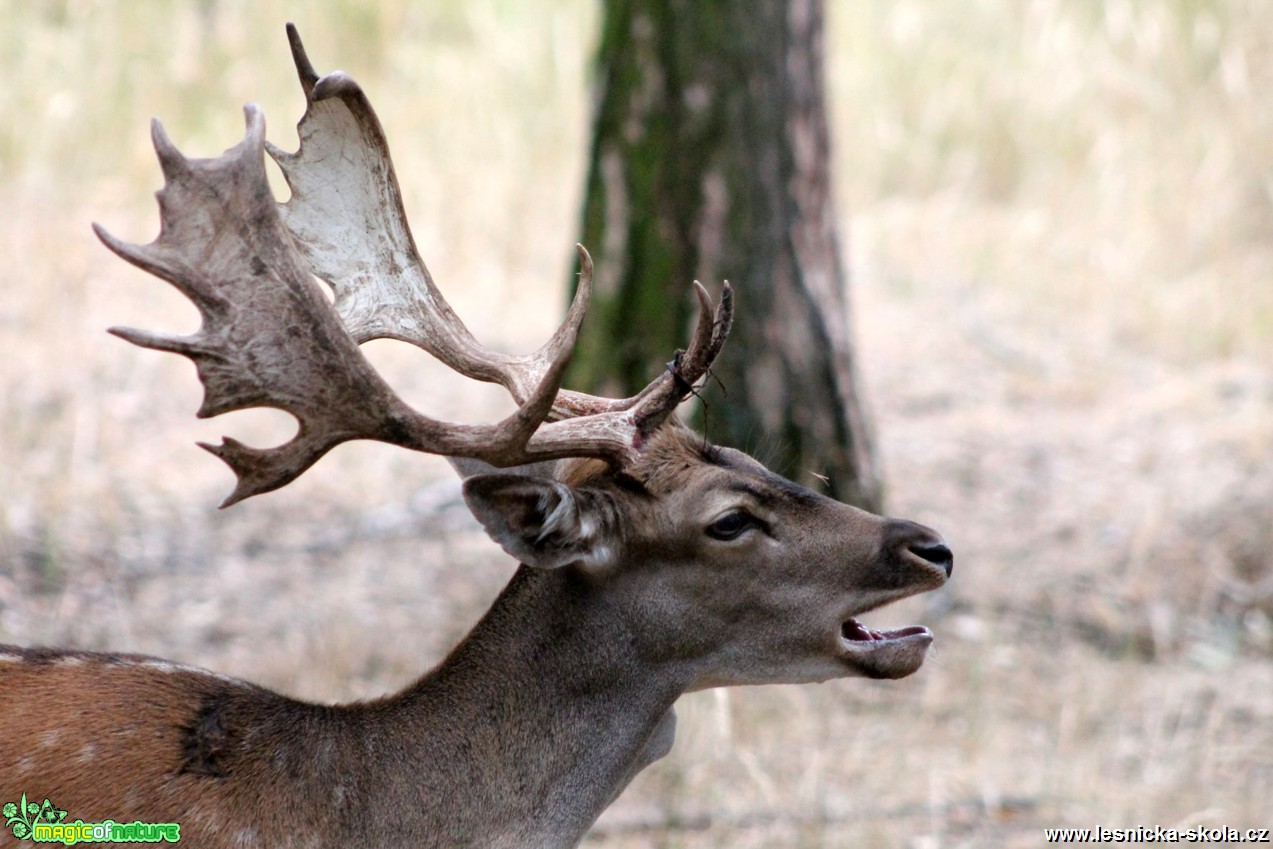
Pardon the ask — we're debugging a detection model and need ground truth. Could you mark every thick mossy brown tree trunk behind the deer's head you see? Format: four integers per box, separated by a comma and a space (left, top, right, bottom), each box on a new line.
566, 0, 881, 509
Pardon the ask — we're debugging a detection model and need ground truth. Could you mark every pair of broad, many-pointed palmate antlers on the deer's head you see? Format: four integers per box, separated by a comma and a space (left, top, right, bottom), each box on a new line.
94, 24, 733, 507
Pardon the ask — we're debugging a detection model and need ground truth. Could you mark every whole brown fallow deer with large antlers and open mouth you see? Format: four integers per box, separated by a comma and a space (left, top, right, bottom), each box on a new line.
0, 25, 952, 849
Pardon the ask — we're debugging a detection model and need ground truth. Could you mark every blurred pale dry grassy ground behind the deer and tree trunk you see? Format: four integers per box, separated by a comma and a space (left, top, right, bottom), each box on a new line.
0, 0, 1273, 849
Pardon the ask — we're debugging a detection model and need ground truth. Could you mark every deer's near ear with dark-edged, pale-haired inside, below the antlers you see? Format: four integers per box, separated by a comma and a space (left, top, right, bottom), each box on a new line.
465, 475, 615, 569
